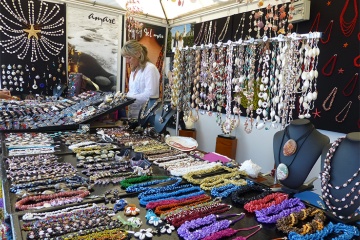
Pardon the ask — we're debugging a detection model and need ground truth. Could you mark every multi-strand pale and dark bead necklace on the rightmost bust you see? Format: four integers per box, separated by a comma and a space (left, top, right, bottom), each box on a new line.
320, 137, 360, 219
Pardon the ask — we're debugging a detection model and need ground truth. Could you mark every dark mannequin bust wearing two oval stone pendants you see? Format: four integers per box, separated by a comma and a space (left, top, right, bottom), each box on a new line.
273, 119, 330, 189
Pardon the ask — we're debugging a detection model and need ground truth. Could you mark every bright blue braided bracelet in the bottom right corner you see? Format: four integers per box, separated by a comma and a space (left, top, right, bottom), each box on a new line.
288, 222, 360, 240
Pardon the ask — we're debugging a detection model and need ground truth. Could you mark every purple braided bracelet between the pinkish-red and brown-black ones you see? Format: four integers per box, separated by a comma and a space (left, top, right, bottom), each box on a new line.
255, 198, 305, 223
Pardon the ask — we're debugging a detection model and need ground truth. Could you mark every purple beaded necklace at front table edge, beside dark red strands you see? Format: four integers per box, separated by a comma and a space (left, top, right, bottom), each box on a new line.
177, 213, 245, 240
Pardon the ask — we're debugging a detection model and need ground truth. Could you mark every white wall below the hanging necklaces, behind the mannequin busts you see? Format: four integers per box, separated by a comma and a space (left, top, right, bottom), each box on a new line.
168, 114, 345, 194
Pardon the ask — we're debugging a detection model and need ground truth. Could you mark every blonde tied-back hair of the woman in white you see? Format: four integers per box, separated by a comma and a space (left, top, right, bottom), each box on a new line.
121, 40, 150, 69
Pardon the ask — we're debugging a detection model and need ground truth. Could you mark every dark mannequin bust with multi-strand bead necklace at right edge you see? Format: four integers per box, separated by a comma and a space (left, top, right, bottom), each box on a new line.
321, 132, 360, 221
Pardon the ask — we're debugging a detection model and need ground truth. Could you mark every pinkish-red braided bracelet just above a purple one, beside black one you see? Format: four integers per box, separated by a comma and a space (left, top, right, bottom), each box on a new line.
244, 192, 289, 212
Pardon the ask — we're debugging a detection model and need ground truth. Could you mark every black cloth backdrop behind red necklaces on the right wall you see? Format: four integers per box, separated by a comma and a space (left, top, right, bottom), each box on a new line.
194, 0, 360, 133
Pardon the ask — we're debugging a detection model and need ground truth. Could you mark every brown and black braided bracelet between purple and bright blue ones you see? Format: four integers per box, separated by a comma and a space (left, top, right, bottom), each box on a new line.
276, 207, 326, 235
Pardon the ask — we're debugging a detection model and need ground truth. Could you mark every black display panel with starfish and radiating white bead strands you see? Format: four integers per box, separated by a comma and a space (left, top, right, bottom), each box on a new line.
0, 0, 67, 97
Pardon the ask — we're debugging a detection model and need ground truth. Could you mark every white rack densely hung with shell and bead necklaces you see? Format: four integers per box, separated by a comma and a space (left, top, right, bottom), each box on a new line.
173, 32, 322, 134
